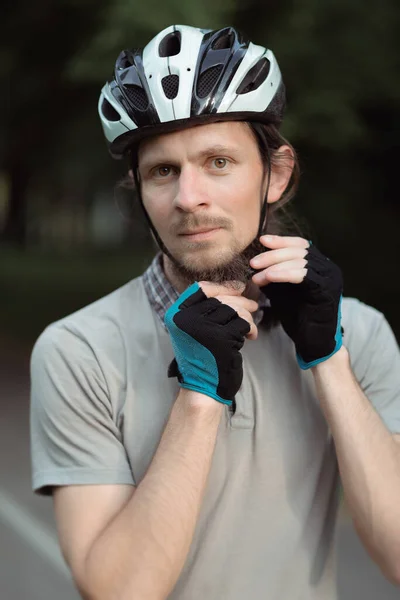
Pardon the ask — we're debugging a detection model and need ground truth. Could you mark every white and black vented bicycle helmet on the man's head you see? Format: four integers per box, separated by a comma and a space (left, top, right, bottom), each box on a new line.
98, 25, 285, 158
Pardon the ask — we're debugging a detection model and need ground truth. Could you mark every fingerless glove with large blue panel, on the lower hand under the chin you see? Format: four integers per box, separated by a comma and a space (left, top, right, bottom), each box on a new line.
165, 283, 250, 405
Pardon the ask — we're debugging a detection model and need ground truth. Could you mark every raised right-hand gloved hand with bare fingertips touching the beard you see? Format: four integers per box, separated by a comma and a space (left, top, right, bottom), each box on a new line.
250, 235, 343, 369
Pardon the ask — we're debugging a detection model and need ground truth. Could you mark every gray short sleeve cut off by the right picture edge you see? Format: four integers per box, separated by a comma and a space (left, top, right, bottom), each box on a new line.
343, 299, 400, 433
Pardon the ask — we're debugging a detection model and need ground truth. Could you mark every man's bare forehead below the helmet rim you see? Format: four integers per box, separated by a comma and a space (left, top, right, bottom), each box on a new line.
138, 121, 256, 161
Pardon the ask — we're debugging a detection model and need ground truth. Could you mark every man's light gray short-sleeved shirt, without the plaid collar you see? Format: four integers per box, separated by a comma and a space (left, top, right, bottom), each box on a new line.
31, 278, 400, 600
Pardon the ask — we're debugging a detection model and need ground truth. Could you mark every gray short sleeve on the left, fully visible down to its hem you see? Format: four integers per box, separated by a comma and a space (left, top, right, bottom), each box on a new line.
30, 324, 134, 495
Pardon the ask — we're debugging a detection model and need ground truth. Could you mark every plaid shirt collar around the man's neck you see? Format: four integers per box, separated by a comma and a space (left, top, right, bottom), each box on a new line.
142, 252, 270, 327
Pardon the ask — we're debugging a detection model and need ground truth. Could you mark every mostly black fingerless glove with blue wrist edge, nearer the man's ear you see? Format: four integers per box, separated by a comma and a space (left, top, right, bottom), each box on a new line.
262, 245, 343, 369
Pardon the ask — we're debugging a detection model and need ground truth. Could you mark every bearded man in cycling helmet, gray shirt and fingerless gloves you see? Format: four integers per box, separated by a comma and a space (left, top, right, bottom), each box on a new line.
31, 26, 400, 600
